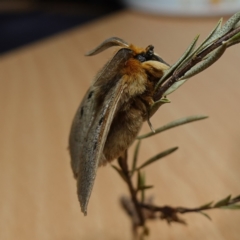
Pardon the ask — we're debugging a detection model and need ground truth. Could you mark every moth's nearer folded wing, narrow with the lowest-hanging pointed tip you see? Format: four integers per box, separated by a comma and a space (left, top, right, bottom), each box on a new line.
77, 79, 125, 215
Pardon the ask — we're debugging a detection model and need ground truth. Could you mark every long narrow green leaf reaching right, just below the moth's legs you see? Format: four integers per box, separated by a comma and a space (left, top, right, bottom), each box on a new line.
137, 115, 208, 139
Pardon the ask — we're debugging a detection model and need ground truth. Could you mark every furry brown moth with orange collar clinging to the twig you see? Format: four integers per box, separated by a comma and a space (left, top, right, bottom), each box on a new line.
69, 37, 169, 215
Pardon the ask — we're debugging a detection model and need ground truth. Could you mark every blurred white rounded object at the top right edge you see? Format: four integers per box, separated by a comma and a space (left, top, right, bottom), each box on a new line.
122, 0, 240, 16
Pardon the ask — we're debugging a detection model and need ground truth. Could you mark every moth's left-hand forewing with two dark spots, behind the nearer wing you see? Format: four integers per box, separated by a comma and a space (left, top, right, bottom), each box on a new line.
69, 49, 131, 177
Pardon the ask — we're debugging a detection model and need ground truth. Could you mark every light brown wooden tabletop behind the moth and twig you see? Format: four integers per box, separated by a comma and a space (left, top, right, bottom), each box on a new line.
0, 12, 240, 240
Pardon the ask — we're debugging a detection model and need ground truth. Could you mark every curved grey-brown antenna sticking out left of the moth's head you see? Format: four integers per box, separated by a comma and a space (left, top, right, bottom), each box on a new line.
85, 37, 129, 56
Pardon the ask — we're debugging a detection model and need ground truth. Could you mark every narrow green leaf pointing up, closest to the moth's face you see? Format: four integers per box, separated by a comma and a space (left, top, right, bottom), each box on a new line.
155, 35, 199, 90
